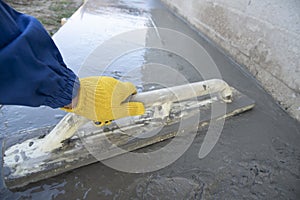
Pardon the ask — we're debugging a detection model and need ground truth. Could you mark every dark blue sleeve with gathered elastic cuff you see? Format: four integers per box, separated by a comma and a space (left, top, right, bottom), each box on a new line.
0, 0, 79, 108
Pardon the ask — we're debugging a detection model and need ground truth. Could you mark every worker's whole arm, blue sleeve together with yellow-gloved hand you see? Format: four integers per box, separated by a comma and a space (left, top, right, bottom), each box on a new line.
0, 0, 145, 122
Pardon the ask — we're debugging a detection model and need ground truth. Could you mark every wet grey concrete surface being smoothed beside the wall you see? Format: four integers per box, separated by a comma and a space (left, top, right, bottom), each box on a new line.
0, 0, 300, 199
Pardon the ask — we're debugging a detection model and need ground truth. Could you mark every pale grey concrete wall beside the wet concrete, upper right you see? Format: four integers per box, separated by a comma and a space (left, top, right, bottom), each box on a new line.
162, 0, 300, 120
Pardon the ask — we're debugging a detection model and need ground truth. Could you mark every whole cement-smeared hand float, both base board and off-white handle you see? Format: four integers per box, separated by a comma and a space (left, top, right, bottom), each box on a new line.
3, 79, 255, 189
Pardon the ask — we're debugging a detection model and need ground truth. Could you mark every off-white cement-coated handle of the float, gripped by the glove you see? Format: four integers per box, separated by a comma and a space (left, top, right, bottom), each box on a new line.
39, 79, 232, 152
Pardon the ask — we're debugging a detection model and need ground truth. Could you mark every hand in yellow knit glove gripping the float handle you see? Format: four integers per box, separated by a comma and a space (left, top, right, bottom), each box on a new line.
62, 76, 145, 126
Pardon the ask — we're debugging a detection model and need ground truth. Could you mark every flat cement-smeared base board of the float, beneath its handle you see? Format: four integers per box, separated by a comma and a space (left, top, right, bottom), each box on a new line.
3, 90, 255, 189
